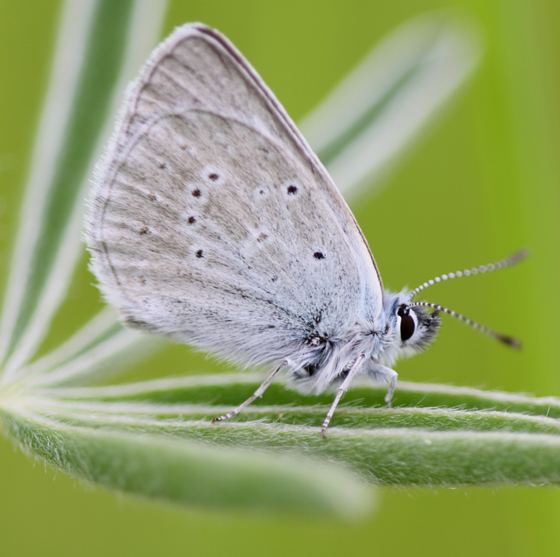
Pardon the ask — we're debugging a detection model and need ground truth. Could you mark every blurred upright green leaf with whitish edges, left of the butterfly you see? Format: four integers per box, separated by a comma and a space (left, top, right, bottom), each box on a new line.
0, 0, 165, 377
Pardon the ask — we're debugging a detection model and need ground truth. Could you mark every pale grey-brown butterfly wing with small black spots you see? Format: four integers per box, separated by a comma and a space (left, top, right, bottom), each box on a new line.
87, 25, 382, 368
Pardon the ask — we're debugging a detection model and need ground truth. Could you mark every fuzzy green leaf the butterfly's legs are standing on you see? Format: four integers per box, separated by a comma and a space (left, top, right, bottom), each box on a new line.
26, 375, 560, 486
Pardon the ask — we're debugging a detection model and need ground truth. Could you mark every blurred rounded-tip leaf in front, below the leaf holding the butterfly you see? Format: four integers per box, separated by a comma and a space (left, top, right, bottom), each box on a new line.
3, 400, 370, 517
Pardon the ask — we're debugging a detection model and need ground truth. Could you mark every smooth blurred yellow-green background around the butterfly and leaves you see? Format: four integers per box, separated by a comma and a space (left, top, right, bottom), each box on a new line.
0, 0, 560, 557
